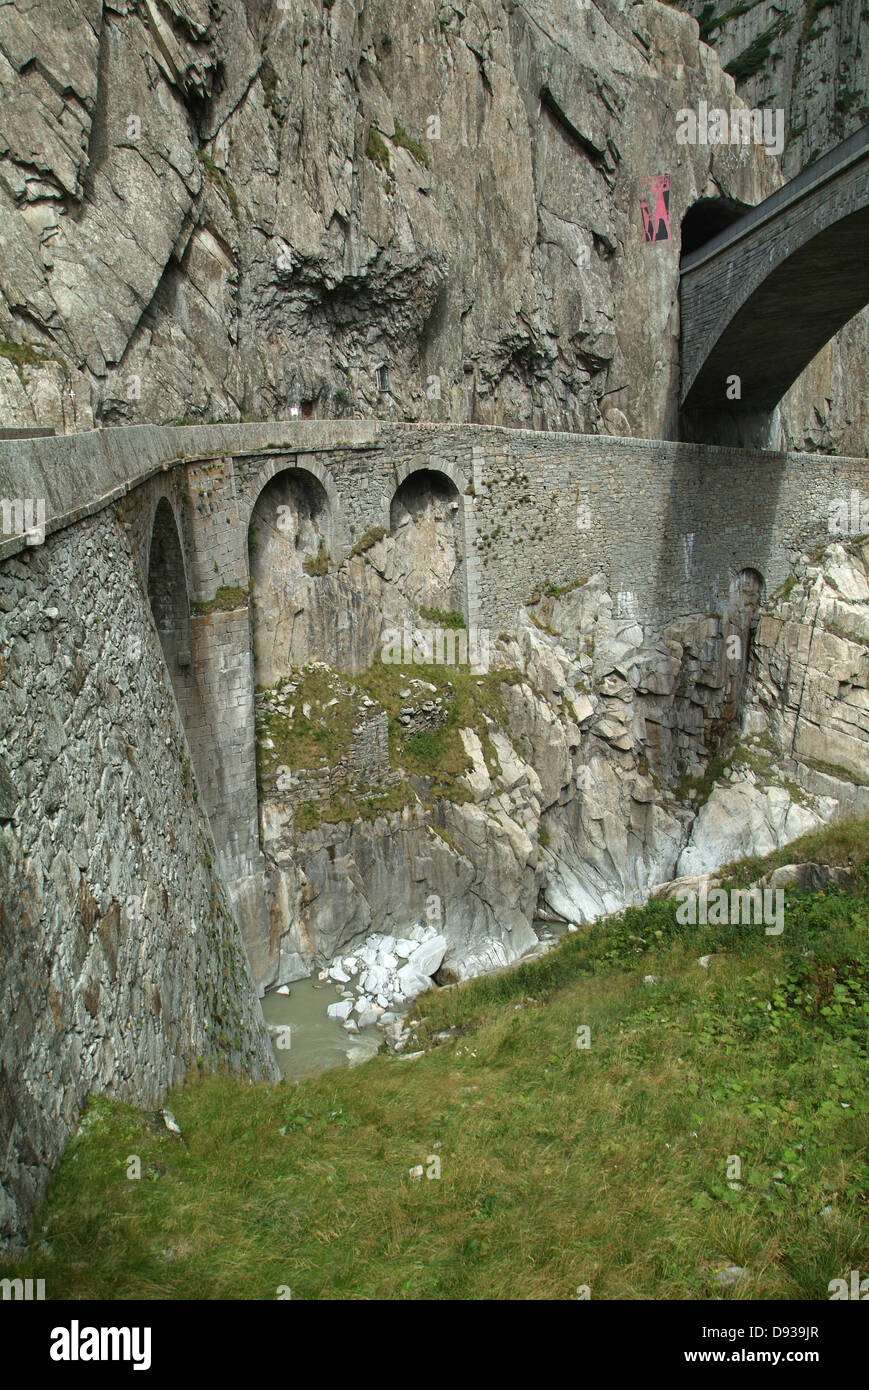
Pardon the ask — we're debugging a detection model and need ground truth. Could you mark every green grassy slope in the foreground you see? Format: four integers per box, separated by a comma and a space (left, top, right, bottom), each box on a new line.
4, 821, 869, 1300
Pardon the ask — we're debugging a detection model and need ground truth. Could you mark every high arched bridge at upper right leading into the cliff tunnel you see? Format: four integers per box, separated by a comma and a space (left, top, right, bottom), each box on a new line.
680, 126, 869, 442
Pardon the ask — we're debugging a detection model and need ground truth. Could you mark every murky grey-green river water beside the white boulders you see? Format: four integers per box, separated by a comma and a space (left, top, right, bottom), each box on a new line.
263, 976, 382, 1081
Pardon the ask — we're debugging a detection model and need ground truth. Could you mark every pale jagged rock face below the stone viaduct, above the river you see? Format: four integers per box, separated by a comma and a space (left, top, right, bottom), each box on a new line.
254, 528, 869, 989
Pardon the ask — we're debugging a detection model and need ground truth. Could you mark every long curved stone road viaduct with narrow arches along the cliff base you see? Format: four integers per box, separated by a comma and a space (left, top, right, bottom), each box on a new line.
0, 420, 869, 984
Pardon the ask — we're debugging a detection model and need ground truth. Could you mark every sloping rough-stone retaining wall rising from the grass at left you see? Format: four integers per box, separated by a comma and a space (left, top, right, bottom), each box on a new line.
0, 512, 277, 1247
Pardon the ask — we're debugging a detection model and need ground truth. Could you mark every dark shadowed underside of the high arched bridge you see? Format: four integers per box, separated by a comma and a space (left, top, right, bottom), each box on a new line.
681, 209, 869, 443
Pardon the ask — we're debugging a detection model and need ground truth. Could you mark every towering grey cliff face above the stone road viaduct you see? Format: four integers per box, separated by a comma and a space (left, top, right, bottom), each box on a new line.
0, 0, 779, 438
